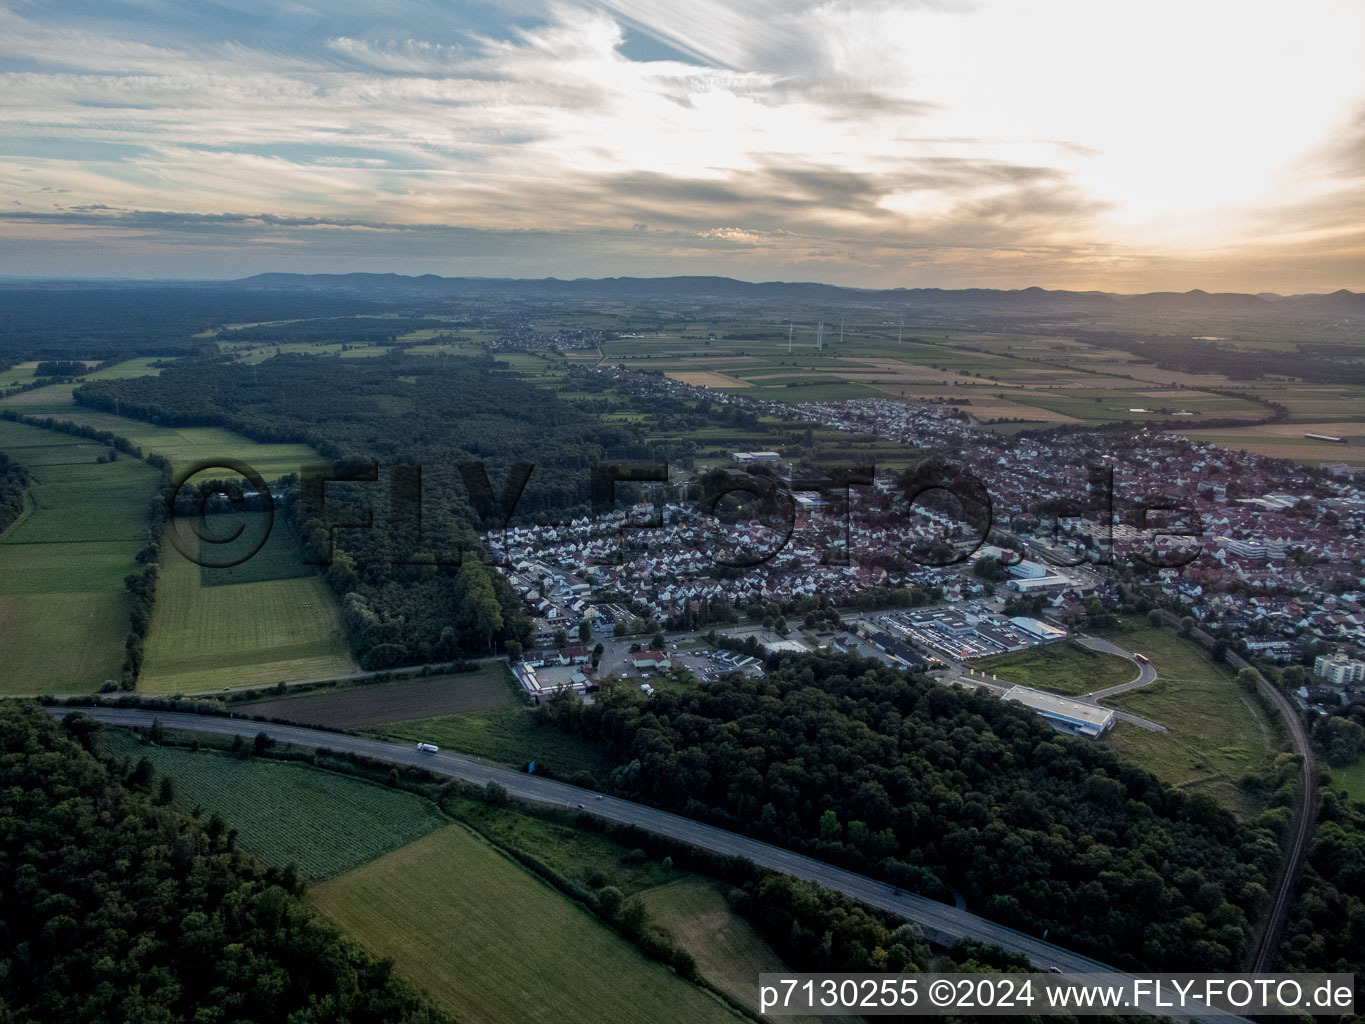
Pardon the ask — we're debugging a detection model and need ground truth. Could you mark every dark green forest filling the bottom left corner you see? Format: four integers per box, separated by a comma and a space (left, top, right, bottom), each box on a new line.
0, 702, 449, 1024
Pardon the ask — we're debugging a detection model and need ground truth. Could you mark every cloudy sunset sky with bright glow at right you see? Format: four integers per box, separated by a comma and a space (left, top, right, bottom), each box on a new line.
0, 0, 1365, 294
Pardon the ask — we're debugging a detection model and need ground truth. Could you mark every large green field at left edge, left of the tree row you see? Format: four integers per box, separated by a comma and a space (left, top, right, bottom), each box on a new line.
0, 421, 158, 694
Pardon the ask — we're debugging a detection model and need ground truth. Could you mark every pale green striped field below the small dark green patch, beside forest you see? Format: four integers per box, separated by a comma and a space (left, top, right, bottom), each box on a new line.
138, 524, 355, 694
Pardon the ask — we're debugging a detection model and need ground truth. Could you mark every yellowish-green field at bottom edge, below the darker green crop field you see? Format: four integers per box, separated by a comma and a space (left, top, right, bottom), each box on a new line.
311, 825, 740, 1024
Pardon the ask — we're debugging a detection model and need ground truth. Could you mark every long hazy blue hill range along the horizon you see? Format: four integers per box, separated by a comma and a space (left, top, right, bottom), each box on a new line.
227, 273, 1365, 315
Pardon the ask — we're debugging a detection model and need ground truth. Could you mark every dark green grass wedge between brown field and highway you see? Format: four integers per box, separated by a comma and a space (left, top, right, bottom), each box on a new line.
366, 703, 610, 778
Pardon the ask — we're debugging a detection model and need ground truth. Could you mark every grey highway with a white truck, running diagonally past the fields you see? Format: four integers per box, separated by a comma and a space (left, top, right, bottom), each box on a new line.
48, 707, 1241, 1021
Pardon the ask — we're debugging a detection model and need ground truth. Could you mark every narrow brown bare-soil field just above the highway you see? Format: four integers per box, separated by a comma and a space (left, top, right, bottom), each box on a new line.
250, 665, 513, 729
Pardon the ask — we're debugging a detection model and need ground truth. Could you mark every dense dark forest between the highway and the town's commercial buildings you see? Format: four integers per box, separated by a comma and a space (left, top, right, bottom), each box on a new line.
541, 655, 1279, 971
